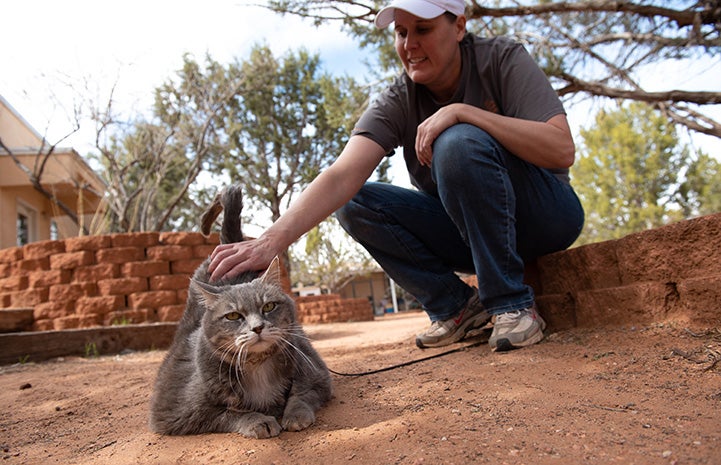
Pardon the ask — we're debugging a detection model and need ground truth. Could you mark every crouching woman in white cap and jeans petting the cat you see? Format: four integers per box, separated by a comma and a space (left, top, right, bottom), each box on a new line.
210, 0, 583, 351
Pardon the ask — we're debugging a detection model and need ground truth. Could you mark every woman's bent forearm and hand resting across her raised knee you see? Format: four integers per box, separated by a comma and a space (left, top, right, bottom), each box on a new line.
416, 103, 576, 168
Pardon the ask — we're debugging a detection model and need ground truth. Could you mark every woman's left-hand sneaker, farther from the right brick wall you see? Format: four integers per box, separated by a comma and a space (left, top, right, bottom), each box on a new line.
416, 293, 491, 349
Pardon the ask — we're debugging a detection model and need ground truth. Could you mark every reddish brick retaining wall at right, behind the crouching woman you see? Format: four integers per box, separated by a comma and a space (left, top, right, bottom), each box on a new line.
527, 214, 721, 329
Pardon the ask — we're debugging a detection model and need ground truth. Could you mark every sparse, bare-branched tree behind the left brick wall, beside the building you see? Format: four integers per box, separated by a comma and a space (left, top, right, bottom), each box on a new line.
91, 57, 243, 232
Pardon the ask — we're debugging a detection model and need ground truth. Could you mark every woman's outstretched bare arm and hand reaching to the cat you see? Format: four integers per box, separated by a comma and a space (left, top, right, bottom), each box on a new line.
208, 136, 386, 281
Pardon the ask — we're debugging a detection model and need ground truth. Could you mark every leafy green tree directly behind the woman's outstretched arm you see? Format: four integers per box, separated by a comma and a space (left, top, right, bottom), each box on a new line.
221, 47, 367, 221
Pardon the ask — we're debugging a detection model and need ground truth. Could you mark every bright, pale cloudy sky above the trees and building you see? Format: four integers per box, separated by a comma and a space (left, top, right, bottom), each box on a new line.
0, 0, 721, 188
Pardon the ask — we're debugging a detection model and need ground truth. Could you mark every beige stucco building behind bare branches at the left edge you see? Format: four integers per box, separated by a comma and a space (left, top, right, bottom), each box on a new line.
0, 96, 105, 249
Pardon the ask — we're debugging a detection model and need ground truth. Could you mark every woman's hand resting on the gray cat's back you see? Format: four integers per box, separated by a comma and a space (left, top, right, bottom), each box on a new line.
208, 239, 278, 282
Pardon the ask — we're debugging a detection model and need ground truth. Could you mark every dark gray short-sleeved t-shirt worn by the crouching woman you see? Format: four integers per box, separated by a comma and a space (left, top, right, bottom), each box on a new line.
352, 34, 568, 195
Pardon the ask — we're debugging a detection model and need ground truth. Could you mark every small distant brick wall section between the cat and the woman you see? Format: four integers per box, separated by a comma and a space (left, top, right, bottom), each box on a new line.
296, 294, 373, 324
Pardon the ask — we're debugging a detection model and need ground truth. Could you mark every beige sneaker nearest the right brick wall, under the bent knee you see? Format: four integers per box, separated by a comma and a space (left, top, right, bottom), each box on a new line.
488, 306, 546, 352
